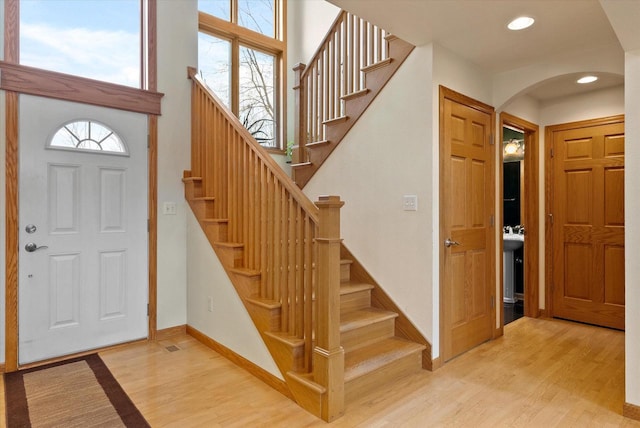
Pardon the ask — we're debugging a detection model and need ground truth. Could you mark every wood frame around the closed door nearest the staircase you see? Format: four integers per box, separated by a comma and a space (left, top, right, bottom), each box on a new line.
433, 85, 502, 362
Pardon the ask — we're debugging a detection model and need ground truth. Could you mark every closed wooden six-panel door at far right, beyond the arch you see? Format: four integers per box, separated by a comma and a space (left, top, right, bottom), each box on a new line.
548, 117, 625, 329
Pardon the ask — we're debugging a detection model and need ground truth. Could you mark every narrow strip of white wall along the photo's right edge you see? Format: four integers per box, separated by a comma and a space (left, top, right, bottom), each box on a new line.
624, 50, 640, 406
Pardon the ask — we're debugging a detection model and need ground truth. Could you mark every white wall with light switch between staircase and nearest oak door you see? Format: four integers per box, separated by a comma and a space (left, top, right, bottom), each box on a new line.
304, 46, 438, 351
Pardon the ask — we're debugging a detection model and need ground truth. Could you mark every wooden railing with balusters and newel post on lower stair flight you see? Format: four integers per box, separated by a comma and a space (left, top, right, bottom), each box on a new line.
188, 68, 344, 412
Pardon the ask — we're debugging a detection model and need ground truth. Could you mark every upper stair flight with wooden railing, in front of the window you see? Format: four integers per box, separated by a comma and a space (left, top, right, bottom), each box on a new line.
291, 11, 414, 188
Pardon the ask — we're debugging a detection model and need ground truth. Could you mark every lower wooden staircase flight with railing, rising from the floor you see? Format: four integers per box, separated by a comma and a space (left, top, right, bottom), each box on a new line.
183, 63, 430, 421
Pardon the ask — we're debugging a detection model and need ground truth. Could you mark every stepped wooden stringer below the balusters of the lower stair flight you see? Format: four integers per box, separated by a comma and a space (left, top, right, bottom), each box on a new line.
183, 171, 326, 417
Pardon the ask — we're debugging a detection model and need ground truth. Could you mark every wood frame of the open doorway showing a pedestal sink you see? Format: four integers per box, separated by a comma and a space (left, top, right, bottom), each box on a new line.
498, 112, 540, 334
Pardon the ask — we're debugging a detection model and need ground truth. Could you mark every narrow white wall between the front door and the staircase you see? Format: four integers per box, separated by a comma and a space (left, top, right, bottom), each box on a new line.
157, 0, 198, 329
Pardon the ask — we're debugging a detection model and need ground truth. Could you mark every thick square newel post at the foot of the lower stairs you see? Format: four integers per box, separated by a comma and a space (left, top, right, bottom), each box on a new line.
313, 196, 344, 422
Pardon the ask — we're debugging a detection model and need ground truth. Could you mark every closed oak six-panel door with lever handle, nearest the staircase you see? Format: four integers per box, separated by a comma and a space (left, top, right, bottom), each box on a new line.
440, 88, 495, 361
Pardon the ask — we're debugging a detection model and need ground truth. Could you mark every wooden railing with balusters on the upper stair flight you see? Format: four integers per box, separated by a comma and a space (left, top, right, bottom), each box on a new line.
293, 11, 389, 163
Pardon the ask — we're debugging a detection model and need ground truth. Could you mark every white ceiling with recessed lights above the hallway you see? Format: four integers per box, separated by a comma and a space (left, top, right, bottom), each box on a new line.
329, 0, 640, 101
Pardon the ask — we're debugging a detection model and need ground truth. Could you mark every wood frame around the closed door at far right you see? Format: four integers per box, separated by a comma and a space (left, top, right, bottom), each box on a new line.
544, 114, 626, 318
